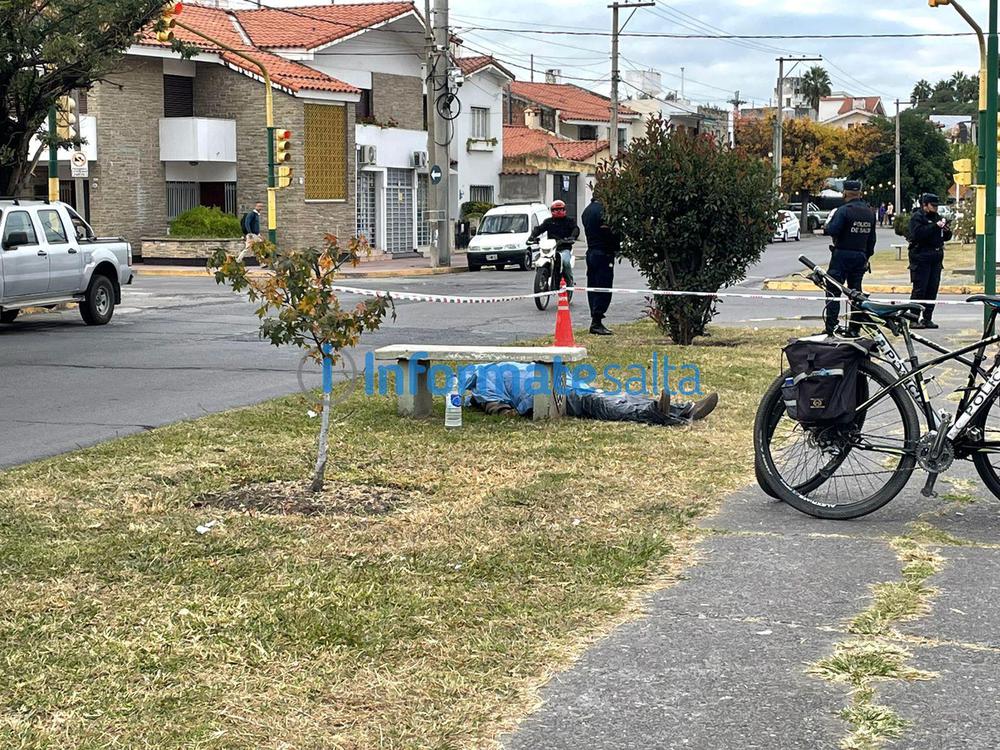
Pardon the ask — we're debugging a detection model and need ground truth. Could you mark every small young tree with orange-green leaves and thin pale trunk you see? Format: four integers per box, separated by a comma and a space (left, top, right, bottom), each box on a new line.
209, 234, 396, 492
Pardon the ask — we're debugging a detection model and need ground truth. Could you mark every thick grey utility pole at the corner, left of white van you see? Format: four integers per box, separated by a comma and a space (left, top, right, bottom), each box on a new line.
427, 0, 453, 267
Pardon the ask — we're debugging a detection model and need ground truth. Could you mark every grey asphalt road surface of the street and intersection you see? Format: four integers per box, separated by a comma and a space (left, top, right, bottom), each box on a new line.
0, 226, 976, 466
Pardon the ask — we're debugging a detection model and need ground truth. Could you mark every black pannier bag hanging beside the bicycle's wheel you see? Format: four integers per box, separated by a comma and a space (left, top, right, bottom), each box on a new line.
781, 337, 875, 425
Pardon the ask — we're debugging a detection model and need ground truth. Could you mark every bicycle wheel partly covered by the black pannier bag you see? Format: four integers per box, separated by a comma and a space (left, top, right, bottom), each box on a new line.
754, 362, 920, 520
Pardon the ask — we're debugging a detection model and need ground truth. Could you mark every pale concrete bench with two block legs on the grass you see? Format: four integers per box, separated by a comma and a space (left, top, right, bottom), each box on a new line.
374, 344, 587, 421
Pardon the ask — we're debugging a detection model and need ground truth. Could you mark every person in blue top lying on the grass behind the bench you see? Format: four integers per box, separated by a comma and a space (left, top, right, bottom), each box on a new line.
463, 362, 719, 425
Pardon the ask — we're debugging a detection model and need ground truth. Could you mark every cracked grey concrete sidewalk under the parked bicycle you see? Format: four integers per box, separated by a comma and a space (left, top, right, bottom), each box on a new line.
505, 470, 1000, 750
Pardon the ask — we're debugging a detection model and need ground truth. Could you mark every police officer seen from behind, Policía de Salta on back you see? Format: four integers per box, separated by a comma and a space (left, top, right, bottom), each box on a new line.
823, 180, 876, 335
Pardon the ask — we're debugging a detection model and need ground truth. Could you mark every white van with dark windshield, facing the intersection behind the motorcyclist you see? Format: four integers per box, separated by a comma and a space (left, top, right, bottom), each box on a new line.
465, 203, 549, 271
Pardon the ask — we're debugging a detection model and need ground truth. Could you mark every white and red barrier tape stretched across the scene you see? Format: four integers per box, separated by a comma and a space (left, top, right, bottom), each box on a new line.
330, 285, 982, 307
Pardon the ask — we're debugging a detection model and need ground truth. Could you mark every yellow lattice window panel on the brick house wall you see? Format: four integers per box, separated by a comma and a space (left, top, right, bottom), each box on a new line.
303, 104, 347, 200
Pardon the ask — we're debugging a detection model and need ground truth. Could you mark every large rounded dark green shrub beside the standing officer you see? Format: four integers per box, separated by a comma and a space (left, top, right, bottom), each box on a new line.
595, 120, 778, 344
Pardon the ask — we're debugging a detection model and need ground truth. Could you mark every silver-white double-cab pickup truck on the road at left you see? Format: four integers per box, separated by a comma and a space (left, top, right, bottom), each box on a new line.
0, 198, 133, 326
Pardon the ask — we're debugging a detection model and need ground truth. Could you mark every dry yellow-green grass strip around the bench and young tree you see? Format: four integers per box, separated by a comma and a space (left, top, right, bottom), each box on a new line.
0, 323, 788, 749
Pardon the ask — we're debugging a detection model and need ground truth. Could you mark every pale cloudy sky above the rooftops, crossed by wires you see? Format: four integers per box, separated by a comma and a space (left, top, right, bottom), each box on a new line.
450, 0, 987, 110
